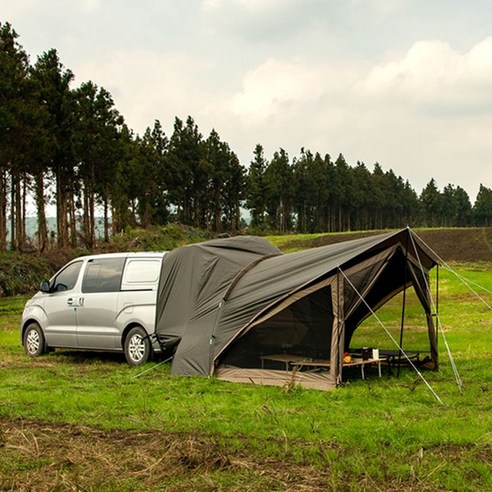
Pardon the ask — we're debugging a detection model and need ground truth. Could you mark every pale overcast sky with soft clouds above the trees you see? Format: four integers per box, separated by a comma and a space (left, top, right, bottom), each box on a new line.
0, 0, 492, 202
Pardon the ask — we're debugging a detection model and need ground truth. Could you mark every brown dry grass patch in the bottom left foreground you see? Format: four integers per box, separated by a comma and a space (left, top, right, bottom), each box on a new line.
0, 418, 334, 492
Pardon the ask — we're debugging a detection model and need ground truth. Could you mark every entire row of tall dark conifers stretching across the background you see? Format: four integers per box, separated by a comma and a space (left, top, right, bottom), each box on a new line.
0, 23, 492, 251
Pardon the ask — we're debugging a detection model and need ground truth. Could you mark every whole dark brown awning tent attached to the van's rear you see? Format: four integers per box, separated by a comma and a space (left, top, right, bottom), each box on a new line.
156, 228, 438, 389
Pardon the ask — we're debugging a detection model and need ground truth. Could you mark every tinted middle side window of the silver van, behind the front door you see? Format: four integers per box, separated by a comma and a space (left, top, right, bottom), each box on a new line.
82, 258, 125, 292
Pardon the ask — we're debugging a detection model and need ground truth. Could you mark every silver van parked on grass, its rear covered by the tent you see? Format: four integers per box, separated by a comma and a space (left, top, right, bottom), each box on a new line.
20, 253, 165, 366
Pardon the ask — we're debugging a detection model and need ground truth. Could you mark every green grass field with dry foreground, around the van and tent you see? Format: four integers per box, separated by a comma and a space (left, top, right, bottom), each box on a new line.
0, 254, 492, 491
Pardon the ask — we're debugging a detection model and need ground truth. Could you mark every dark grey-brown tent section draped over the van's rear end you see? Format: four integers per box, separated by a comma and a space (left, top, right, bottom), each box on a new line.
155, 236, 282, 374
